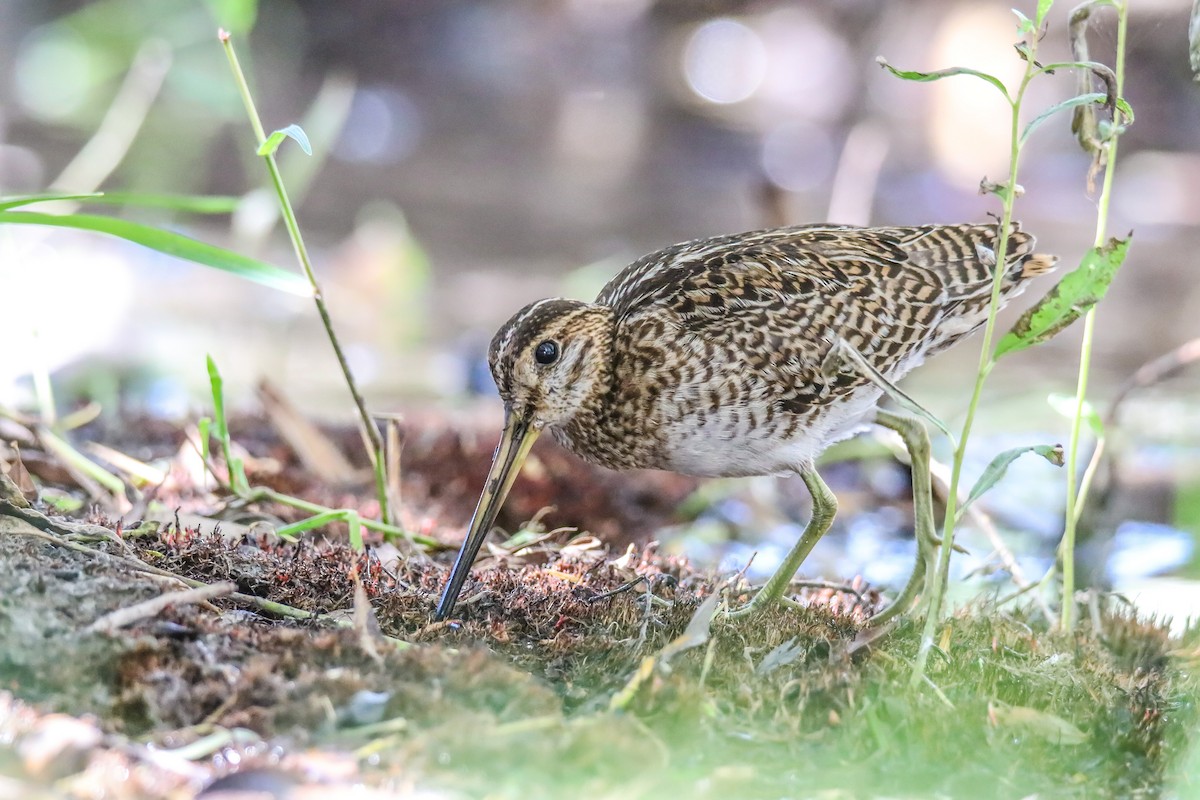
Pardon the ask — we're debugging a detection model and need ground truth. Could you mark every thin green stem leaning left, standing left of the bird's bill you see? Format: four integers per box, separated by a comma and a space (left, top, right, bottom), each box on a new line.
220, 31, 394, 524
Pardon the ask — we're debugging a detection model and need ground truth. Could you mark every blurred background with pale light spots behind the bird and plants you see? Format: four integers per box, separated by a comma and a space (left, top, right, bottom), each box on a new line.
0, 0, 1200, 614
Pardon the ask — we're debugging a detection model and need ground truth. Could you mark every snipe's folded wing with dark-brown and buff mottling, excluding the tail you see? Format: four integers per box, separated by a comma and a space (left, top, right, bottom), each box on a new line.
609, 227, 964, 408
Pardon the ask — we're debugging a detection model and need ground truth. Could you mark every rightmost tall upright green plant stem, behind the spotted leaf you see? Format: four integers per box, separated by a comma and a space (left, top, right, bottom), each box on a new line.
1060, 2, 1128, 631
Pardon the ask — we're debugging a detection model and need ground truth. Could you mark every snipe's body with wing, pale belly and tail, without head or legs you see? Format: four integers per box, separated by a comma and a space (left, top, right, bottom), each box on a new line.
560, 224, 1054, 475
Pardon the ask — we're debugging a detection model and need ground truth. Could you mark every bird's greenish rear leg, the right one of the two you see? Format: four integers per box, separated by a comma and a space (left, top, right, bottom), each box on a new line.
870, 409, 941, 625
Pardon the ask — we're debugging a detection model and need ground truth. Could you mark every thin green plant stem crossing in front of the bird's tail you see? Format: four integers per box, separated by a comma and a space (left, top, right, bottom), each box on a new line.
912, 48, 1037, 686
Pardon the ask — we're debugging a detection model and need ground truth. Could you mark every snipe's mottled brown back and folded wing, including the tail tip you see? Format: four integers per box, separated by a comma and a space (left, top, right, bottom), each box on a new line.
598, 223, 1055, 395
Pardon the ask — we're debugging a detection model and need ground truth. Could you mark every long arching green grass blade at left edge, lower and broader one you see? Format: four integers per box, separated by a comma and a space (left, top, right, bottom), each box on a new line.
0, 211, 312, 296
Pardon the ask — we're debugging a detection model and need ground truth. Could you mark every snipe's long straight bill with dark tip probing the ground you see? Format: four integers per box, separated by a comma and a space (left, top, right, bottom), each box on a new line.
433, 405, 541, 620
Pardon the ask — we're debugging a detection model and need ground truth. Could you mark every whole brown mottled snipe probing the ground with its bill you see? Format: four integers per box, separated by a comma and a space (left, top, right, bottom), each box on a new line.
434, 222, 1057, 622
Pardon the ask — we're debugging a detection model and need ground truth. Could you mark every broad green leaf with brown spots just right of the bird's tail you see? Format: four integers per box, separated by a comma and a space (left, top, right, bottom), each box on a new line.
995, 236, 1132, 360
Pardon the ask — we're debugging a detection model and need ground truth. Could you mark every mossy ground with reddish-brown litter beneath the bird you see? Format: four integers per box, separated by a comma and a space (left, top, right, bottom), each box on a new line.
0, 421, 1196, 798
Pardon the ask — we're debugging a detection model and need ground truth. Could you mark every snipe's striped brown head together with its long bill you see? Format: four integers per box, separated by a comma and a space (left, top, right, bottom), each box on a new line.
436, 299, 613, 619
